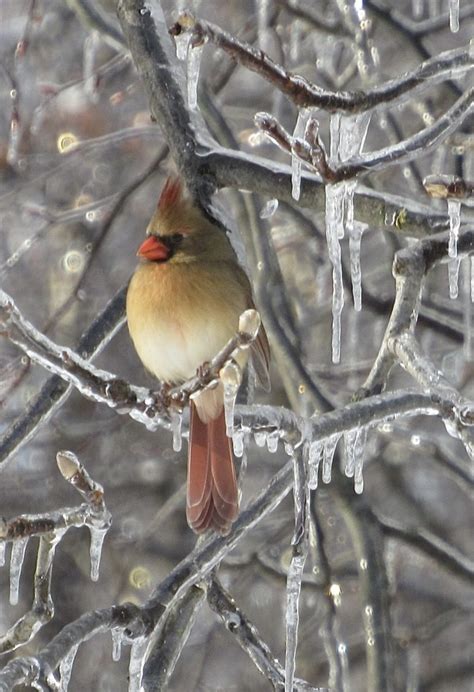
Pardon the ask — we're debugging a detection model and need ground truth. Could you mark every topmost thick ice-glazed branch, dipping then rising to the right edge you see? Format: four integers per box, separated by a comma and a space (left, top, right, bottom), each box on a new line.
170, 12, 474, 113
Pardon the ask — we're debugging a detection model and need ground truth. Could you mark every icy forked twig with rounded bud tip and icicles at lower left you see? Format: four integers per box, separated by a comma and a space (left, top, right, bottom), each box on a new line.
0, 452, 111, 654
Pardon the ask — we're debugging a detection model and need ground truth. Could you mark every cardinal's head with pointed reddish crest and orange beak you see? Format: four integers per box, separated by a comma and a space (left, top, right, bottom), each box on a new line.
137, 178, 232, 264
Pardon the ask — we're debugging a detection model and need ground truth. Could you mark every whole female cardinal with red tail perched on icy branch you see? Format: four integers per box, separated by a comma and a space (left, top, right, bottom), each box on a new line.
127, 178, 270, 534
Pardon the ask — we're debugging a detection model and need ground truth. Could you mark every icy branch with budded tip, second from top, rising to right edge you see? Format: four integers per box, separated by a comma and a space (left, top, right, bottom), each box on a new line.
255, 89, 474, 183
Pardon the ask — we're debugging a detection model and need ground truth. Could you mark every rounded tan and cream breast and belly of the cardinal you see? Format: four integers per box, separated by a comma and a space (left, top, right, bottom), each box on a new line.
127, 262, 248, 382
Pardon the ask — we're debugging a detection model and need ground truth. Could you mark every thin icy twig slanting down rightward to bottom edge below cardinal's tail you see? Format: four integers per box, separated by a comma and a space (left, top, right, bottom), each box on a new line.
207, 578, 320, 692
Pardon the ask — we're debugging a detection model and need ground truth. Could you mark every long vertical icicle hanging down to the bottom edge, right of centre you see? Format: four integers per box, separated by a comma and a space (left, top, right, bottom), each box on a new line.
285, 551, 306, 692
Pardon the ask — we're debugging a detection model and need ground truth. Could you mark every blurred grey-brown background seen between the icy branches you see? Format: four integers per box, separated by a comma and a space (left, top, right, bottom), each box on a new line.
0, 0, 474, 692
